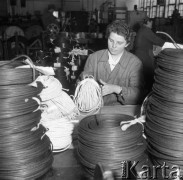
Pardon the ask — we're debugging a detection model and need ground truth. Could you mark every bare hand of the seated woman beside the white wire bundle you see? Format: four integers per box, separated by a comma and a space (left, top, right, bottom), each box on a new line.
100, 79, 122, 96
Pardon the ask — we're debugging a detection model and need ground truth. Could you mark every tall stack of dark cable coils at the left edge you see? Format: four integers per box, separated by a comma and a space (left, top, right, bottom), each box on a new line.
0, 61, 53, 180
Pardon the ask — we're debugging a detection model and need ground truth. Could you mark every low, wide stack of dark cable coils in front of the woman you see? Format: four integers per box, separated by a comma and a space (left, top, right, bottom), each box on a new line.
77, 114, 145, 178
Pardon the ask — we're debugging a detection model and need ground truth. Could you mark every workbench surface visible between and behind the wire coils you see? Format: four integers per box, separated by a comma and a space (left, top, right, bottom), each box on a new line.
41, 105, 141, 180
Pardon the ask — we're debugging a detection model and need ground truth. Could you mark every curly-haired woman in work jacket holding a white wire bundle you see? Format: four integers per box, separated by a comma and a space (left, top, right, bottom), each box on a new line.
80, 20, 144, 105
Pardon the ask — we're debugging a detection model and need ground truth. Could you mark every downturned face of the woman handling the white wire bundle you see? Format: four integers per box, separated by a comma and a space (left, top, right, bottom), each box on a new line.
108, 32, 128, 55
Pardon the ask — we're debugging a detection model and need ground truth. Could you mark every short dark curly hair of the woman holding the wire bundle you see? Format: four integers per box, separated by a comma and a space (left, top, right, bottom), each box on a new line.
106, 20, 130, 42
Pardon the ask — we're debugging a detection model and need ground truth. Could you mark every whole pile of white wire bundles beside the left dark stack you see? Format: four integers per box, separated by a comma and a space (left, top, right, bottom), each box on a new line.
36, 76, 79, 152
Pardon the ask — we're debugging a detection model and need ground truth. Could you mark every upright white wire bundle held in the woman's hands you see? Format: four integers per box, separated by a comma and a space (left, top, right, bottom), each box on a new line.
74, 76, 103, 113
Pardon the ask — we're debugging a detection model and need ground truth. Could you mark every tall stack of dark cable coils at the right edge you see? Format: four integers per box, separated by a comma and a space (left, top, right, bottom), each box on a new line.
145, 49, 183, 178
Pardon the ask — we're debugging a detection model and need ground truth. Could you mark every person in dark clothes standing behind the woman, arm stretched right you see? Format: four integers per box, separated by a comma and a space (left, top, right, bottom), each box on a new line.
134, 17, 165, 93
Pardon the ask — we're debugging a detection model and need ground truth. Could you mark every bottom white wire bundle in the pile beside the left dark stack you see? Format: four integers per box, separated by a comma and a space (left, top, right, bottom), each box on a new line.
41, 118, 74, 152
